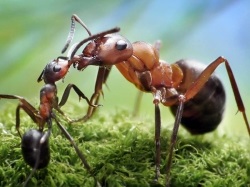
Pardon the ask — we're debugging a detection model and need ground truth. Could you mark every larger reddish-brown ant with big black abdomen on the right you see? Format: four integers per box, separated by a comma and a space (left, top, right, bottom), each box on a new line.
61, 15, 250, 186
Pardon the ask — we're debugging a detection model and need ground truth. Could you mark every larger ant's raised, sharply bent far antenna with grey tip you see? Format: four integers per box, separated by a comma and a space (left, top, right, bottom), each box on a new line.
62, 14, 92, 53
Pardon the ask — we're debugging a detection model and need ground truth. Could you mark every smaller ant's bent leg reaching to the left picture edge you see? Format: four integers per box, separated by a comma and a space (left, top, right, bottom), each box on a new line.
0, 94, 43, 138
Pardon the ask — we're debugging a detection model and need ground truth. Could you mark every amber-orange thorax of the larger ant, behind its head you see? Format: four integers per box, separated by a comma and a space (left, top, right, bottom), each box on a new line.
115, 42, 183, 106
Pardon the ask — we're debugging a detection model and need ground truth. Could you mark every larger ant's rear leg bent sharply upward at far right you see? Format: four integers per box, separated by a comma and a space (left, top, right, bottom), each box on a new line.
184, 57, 250, 136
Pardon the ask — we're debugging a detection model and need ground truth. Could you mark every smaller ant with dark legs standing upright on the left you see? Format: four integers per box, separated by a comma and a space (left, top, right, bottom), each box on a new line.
0, 49, 99, 186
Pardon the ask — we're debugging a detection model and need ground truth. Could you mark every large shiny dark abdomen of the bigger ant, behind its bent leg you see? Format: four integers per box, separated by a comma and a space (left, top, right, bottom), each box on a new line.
170, 60, 226, 134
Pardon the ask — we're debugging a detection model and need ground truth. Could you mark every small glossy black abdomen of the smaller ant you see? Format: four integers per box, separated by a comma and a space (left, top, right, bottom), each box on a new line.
22, 129, 50, 169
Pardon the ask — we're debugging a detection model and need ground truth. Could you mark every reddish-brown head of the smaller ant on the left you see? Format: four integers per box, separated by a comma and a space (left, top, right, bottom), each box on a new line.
37, 57, 70, 83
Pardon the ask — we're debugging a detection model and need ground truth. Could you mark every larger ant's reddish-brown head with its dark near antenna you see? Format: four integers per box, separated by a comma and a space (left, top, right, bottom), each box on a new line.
67, 27, 133, 70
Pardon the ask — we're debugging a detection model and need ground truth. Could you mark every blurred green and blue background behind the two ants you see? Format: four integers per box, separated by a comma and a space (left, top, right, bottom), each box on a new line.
0, 0, 250, 137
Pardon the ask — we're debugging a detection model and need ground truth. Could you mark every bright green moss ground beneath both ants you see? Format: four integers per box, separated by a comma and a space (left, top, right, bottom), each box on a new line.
0, 105, 250, 187
